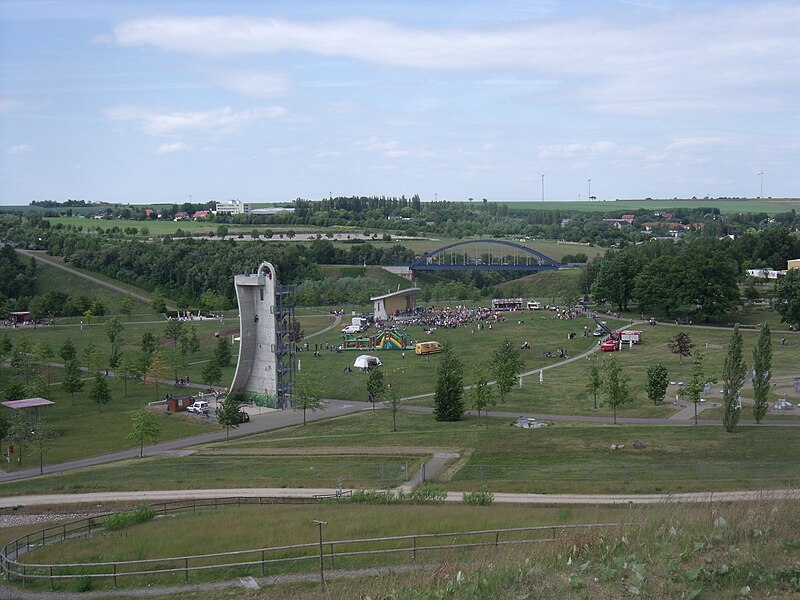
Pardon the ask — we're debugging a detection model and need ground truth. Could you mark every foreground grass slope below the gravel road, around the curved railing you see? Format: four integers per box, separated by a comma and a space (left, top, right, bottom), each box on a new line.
12, 501, 800, 600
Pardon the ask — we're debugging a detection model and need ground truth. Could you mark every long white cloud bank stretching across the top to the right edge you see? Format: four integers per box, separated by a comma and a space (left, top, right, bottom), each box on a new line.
114, 1, 800, 116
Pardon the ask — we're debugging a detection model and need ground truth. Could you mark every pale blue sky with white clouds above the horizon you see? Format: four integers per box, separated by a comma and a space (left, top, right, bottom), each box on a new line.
0, 0, 800, 205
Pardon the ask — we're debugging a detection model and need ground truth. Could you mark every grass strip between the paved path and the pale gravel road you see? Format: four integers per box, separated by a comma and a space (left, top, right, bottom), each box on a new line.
0, 411, 800, 495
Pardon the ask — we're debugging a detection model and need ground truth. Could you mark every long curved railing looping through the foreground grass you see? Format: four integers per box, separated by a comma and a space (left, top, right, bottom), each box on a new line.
0, 497, 624, 588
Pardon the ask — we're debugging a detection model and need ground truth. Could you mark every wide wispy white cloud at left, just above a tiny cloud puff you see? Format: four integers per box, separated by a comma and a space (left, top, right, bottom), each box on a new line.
106, 106, 286, 136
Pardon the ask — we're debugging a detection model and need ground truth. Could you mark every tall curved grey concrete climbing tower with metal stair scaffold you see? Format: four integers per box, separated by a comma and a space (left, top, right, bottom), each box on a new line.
231, 262, 295, 408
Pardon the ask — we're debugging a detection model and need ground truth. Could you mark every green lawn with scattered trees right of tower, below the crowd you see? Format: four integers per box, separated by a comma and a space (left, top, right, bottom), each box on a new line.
301, 311, 800, 417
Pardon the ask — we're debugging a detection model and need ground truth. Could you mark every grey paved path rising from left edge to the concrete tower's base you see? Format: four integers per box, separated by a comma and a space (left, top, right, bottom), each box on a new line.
0, 400, 371, 482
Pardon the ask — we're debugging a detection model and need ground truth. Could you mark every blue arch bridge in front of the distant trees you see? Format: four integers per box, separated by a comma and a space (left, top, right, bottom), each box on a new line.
408, 240, 562, 273
